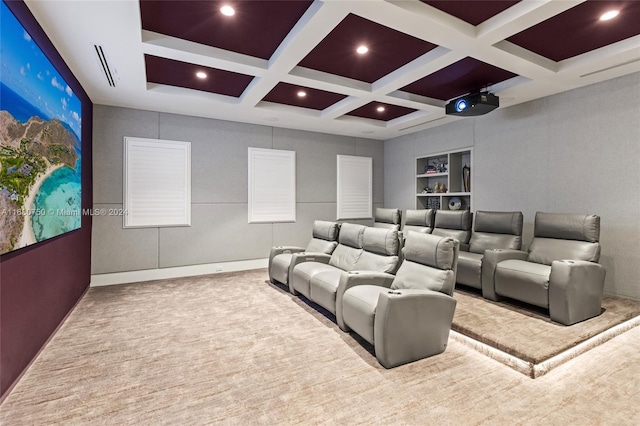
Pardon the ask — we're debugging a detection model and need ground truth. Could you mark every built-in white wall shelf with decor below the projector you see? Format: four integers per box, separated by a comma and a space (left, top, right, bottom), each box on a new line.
416, 148, 473, 210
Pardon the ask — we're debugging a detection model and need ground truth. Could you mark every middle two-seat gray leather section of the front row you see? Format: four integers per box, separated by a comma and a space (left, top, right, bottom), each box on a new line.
289, 223, 399, 323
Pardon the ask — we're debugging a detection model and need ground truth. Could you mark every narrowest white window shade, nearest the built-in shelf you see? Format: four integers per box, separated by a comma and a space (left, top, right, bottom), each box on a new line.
337, 155, 373, 220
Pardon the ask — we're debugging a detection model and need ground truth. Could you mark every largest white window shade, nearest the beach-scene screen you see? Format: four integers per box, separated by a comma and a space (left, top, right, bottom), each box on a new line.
123, 137, 191, 228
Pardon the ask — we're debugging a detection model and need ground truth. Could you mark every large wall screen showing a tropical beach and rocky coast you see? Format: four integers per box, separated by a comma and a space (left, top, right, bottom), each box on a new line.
0, 1, 82, 254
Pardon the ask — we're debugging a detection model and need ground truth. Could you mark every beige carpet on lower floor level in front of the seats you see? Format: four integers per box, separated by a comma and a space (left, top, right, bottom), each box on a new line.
0, 270, 640, 426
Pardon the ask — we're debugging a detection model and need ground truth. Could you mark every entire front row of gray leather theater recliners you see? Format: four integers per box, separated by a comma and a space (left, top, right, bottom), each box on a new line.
269, 221, 459, 368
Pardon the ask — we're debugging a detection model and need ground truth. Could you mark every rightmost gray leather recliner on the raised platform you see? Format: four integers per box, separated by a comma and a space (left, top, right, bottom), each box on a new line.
482, 212, 606, 325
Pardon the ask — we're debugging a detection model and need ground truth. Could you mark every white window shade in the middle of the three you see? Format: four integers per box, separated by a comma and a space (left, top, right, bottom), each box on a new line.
249, 148, 296, 223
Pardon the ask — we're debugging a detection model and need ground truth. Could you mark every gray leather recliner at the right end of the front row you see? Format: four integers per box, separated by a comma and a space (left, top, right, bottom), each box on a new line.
337, 232, 458, 368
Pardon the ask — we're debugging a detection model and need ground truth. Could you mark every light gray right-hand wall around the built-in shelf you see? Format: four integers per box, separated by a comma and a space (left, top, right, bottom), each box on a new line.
384, 73, 640, 299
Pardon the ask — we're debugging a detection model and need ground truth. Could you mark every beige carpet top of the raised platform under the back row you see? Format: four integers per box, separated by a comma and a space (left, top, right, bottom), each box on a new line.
451, 288, 640, 364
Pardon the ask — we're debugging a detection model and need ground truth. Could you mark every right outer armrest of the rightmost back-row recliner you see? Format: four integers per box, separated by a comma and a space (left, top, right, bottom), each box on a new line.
549, 260, 606, 325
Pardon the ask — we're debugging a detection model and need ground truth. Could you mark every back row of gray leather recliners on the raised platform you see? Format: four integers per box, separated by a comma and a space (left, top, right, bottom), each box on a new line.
382, 210, 606, 325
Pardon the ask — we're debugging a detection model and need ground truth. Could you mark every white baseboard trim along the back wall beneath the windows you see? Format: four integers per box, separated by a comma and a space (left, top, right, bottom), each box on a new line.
91, 258, 269, 287
